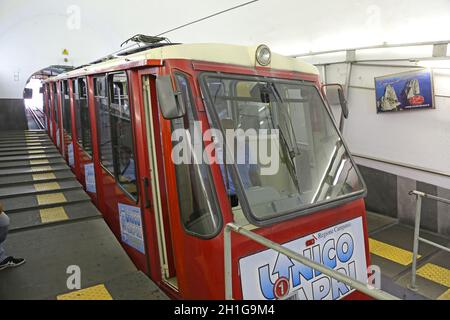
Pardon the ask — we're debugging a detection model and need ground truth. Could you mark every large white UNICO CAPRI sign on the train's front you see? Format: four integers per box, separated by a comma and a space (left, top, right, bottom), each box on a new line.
239, 217, 367, 300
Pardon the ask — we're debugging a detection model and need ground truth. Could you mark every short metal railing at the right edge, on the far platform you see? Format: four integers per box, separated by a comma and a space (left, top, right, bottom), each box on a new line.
409, 190, 450, 291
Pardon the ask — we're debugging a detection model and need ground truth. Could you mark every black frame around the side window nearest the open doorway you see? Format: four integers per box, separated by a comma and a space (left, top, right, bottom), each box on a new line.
106, 70, 140, 205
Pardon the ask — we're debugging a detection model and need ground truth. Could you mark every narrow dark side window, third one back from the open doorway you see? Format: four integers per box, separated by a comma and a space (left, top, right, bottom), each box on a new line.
74, 78, 92, 156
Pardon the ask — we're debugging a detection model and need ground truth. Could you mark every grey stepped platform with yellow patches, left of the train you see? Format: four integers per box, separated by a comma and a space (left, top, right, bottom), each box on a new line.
0, 132, 167, 300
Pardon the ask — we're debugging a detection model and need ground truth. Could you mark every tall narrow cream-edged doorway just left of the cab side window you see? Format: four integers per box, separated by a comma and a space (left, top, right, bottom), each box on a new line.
141, 74, 179, 291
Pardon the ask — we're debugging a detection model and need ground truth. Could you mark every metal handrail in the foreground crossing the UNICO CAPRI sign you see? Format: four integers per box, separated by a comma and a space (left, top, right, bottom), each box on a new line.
224, 223, 400, 300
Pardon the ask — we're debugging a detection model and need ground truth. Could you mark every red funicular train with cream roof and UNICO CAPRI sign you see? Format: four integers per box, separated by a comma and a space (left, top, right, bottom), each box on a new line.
45, 40, 369, 299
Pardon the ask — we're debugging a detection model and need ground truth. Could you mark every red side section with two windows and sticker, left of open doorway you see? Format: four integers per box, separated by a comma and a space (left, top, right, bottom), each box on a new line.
93, 71, 153, 273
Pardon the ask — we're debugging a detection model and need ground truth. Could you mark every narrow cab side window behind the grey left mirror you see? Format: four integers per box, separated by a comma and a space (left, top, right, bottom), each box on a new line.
172, 74, 221, 238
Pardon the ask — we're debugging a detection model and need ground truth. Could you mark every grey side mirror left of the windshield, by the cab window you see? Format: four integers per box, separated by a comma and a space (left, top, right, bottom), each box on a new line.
156, 76, 186, 120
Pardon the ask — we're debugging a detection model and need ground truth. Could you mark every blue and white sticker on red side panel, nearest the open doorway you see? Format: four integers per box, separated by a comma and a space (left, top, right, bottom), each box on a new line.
119, 203, 145, 254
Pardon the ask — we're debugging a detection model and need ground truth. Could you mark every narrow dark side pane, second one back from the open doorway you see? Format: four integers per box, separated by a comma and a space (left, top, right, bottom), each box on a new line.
94, 76, 114, 173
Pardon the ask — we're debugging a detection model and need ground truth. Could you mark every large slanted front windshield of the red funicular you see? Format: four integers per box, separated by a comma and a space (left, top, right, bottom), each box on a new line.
202, 74, 364, 223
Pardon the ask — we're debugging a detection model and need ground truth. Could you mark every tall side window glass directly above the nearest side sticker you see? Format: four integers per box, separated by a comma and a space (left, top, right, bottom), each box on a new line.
108, 72, 138, 199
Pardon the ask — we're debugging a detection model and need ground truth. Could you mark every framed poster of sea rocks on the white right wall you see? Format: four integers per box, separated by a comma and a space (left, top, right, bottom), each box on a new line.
375, 69, 435, 113
